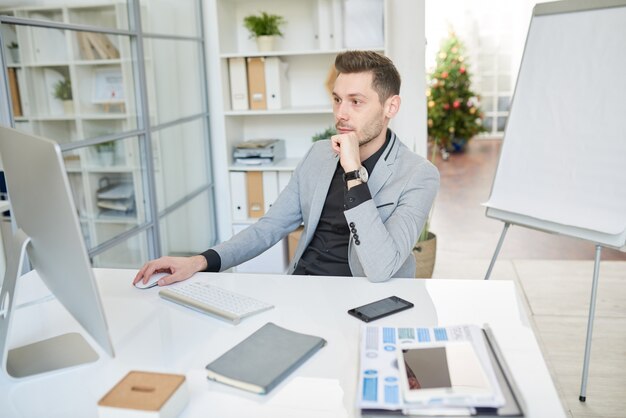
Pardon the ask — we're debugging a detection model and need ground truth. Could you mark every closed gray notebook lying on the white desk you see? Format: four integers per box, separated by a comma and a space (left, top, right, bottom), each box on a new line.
206, 322, 326, 394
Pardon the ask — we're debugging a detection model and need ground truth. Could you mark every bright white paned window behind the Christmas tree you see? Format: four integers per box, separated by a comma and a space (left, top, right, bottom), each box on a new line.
426, 0, 536, 137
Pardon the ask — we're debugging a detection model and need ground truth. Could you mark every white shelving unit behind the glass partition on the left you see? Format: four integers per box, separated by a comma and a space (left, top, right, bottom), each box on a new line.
0, 3, 147, 267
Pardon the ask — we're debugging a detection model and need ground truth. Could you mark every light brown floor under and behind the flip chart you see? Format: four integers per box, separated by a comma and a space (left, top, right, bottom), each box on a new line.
431, 140, 626, 418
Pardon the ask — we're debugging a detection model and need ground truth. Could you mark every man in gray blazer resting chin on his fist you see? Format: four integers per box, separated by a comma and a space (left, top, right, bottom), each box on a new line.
133, 51, 439, 286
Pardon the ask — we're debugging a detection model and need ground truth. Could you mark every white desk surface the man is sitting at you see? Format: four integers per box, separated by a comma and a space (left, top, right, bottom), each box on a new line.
0, 269, 565, 418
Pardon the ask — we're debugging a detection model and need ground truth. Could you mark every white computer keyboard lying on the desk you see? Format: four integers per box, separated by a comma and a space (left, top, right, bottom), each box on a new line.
159, 282, 274, 324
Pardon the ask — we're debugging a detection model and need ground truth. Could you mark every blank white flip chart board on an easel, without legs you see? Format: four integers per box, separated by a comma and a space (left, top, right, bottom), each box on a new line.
485, 1, 626, 248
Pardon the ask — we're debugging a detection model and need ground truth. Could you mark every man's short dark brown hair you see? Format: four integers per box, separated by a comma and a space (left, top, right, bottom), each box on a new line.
335, 51, 400, 103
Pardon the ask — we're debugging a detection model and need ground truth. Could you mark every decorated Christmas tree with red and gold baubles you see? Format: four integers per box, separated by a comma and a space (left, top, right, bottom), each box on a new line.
426, 31, 485, 153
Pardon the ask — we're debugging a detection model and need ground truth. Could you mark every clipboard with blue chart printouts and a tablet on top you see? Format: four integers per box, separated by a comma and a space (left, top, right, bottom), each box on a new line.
357, 325, 524, 417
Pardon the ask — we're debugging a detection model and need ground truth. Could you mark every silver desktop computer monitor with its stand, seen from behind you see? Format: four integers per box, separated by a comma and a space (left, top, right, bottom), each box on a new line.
0, 126, 114, 378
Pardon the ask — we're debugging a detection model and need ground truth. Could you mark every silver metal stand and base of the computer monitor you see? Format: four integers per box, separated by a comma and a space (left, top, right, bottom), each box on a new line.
0, 229, 99, 379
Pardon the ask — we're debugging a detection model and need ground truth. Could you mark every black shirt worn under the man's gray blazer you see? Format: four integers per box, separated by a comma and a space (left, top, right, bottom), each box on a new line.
293, 130, 391, 276
